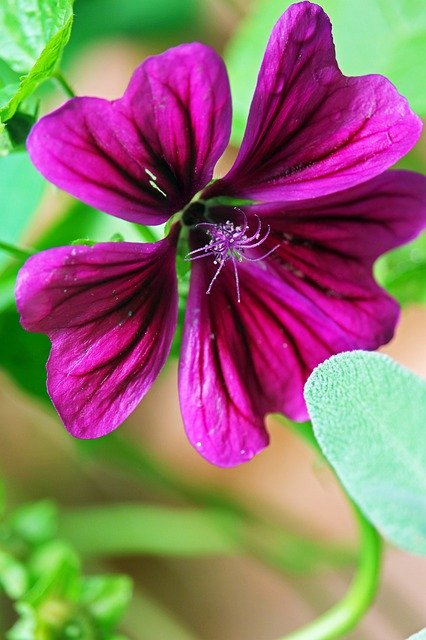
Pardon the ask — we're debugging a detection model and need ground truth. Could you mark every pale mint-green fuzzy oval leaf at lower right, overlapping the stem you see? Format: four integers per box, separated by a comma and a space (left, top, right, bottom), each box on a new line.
305, 351, 426, 554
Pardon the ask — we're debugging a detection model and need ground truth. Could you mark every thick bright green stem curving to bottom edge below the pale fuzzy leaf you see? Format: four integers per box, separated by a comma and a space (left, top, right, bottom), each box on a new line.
281, 505, 381, 640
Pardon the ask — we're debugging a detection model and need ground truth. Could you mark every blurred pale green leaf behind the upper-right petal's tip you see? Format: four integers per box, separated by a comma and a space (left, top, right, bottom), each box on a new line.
225, 0, 426, 144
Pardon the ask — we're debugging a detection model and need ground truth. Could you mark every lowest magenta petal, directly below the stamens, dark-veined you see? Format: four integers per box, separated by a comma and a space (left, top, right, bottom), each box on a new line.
179, 252, 359, 467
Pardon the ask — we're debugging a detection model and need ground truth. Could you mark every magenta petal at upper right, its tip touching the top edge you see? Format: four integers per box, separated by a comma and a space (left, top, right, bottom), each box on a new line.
220, 2, 421, 201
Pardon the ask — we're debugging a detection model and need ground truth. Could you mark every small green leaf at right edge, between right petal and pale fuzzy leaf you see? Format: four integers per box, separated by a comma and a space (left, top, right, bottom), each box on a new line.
374, 233, 426, 306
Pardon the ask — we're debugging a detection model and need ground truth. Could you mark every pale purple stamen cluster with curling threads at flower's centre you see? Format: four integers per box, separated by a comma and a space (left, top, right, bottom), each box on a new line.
185, 212, 279, 302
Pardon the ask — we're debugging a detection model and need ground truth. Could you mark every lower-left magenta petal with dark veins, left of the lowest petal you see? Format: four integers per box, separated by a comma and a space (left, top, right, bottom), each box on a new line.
16, 238, 177, 438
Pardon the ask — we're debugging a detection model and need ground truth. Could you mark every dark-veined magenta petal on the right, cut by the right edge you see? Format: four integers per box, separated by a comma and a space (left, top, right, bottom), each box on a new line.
246, 171, 426, 349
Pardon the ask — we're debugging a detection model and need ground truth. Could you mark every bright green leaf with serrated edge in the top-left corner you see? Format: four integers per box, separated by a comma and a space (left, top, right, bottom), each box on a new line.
0, 0, 73, 122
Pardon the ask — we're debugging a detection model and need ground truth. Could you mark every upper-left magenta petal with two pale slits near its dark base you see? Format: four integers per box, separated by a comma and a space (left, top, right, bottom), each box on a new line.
28, 43, 231, 224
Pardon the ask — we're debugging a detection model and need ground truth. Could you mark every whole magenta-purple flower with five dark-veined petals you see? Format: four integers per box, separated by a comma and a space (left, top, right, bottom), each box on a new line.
17, 2, 426, 466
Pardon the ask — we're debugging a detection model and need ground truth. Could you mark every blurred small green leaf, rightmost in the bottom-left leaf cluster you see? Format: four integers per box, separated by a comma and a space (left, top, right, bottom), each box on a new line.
80, 576, 132, 632
